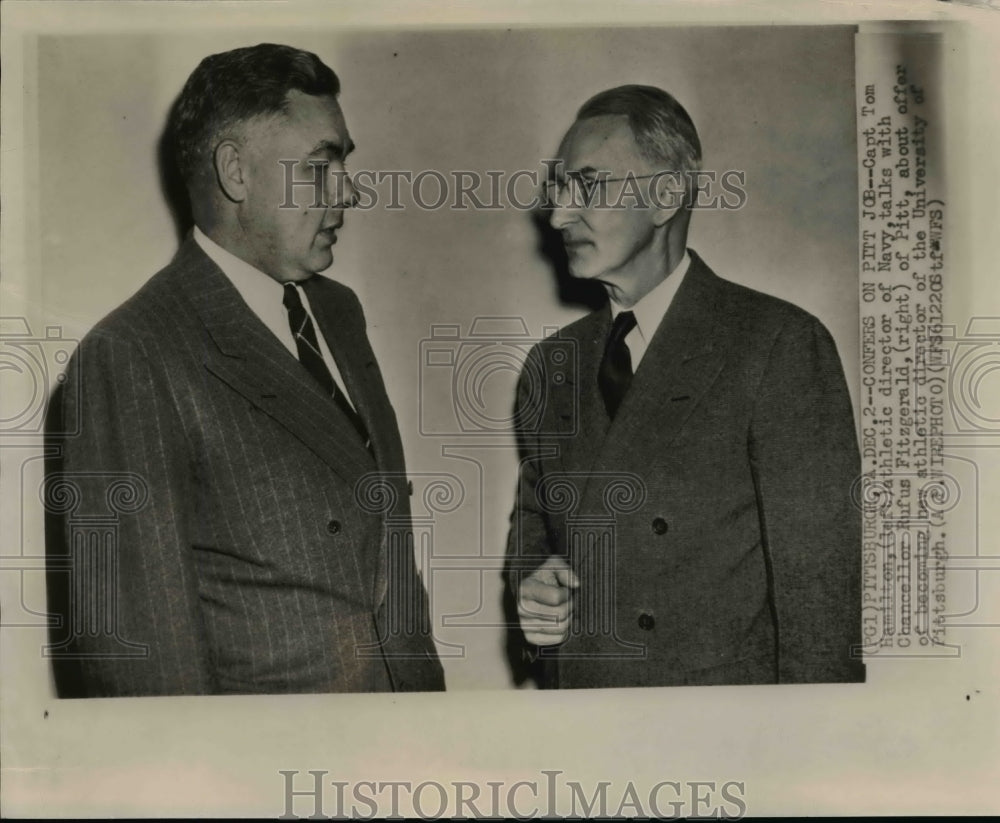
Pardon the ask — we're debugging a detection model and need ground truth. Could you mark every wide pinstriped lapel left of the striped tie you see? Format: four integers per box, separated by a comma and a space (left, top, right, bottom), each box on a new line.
175, 238, 373, 485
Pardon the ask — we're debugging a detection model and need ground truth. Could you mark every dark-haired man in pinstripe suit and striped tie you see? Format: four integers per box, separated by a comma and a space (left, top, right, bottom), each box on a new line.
47, 44, 444, 696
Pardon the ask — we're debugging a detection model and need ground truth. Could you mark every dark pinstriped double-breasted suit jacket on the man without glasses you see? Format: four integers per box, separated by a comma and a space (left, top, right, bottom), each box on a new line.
46, 237, 444, 696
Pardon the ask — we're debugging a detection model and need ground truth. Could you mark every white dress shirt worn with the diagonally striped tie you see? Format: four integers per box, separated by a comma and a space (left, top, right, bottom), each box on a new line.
194, 226, 353, 405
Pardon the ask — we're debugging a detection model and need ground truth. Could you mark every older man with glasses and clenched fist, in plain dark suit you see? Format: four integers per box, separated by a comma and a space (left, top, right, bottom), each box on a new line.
508, 86, 864, 688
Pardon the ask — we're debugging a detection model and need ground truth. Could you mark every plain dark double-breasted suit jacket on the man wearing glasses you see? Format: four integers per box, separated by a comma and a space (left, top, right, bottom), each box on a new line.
508, 253, 864, 688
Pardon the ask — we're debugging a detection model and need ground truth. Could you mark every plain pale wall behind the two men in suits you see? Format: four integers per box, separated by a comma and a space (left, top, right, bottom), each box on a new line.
33, 27, 858, 689
